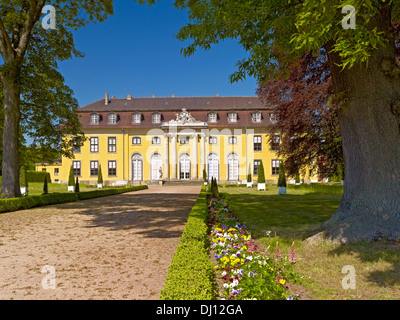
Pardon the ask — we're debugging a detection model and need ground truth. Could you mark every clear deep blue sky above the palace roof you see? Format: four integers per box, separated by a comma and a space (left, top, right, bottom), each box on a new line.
60, 0, 257, 106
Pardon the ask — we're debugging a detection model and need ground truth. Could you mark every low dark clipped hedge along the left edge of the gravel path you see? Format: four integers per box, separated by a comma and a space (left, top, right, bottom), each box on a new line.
0, 185, 148, 213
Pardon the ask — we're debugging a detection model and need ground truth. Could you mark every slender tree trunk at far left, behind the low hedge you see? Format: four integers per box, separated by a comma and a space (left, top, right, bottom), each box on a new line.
1, 72, 21, 198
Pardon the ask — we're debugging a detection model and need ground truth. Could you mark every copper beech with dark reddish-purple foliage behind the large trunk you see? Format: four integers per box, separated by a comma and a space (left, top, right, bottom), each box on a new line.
257, 50, 343, 179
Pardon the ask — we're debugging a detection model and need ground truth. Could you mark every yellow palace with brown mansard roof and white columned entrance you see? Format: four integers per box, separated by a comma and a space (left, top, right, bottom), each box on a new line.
36, 94, 316, 185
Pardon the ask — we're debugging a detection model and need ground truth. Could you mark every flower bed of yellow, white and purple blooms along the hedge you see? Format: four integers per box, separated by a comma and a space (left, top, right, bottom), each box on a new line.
208, 197, 296, 300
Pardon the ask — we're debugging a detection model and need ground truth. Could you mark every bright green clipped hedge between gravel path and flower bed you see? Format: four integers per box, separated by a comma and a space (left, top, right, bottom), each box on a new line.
160, 186, 217, 300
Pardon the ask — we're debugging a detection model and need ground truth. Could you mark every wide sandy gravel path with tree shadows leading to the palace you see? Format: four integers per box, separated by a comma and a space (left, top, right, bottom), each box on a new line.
0, 186, 201, 300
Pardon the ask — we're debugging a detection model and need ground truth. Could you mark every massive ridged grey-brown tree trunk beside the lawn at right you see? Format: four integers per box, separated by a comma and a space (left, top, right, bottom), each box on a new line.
319, 13, 400, 243
